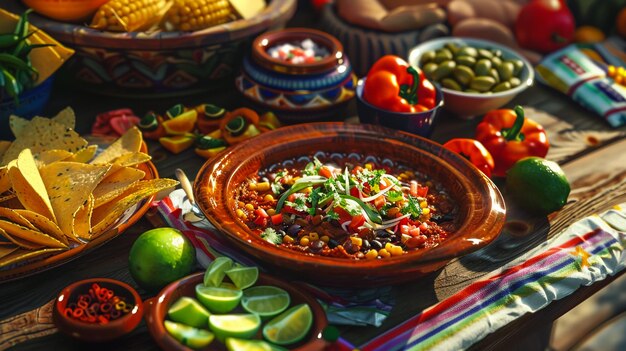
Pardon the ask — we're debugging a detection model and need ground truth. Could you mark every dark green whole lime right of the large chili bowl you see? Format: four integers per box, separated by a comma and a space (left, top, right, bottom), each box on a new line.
506, 157, 570, 215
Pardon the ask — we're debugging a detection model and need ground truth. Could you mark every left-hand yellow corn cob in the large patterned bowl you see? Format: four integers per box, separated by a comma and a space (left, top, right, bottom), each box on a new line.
91, 0, 172, 32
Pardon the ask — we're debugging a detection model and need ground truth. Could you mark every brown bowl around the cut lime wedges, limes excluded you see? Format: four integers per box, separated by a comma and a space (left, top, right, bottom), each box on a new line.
145, 272, 328, 351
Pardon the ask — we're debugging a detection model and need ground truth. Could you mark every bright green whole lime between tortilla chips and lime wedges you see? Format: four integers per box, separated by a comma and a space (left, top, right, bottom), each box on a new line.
128, 228, 196, 290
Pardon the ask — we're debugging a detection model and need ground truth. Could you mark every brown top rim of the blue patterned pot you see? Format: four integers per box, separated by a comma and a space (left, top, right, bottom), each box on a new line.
252, 28, 344, 74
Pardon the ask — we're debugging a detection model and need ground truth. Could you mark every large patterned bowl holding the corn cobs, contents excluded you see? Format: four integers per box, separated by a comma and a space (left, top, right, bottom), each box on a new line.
3, 0, 296, 97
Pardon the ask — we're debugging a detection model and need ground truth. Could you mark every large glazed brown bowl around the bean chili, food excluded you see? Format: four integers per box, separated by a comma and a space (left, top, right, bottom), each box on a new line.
194, 123, 506, 287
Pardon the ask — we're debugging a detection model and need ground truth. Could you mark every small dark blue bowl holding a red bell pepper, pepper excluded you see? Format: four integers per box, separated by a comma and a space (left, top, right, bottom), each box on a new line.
356, 78, 443, 138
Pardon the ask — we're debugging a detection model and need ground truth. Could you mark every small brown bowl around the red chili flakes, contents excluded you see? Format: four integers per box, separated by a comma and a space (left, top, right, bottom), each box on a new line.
53, 278, 144, 341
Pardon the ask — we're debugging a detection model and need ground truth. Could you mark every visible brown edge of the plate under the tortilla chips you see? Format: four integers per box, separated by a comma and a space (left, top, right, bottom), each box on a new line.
0, 157, 159, 283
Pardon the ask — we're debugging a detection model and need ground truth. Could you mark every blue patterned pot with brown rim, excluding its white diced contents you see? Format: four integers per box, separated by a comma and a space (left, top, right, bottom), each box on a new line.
236, 28, 356, 122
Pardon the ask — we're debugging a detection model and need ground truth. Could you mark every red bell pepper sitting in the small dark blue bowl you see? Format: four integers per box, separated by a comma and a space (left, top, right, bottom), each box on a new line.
363, 55, 435, 113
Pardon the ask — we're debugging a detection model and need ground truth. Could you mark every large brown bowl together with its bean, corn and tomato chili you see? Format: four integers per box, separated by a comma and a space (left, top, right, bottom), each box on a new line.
194, 123, 506, 287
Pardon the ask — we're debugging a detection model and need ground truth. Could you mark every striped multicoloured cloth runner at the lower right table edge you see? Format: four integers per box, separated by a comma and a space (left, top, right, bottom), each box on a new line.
362, 204, 626, 351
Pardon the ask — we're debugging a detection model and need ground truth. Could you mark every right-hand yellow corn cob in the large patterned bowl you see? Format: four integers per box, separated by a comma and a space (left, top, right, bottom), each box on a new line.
167, 0, 236, 31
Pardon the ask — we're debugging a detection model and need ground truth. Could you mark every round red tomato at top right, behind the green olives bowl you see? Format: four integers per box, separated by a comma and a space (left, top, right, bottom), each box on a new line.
515, 0, 576, 53
